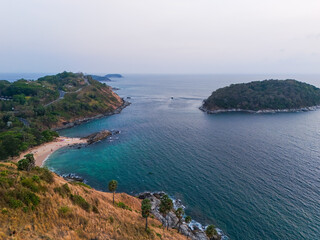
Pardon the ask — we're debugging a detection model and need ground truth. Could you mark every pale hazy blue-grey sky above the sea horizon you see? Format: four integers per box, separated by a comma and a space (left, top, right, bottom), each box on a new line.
0, 0, 320, 74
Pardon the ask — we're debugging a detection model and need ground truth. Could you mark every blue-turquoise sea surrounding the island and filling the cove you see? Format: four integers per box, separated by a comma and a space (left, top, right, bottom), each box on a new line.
45, 75, 320, 240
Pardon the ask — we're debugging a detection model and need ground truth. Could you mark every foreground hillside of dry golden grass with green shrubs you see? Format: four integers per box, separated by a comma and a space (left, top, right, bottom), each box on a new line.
0, 163, 186, 240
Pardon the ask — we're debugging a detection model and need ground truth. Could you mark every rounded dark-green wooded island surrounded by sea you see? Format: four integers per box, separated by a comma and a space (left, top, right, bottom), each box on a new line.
200, 79, 320, 113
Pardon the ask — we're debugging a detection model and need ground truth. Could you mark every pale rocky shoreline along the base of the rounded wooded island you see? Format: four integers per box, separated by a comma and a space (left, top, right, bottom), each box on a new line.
199, 106, 320, 114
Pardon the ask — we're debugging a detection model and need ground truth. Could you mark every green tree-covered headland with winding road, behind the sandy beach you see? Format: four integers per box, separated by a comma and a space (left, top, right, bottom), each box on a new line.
0, 72, 124, 160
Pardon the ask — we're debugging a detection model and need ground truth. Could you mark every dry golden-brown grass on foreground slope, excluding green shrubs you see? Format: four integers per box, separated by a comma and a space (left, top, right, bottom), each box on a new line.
0, 163, 186, 240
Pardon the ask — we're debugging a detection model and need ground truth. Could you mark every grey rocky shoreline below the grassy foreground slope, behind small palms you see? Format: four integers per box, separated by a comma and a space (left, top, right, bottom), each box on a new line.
136, 192, 221, 240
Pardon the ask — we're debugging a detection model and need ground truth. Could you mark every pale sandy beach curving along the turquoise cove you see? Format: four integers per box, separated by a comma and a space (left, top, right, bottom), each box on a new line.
15, 137, 87, 166
